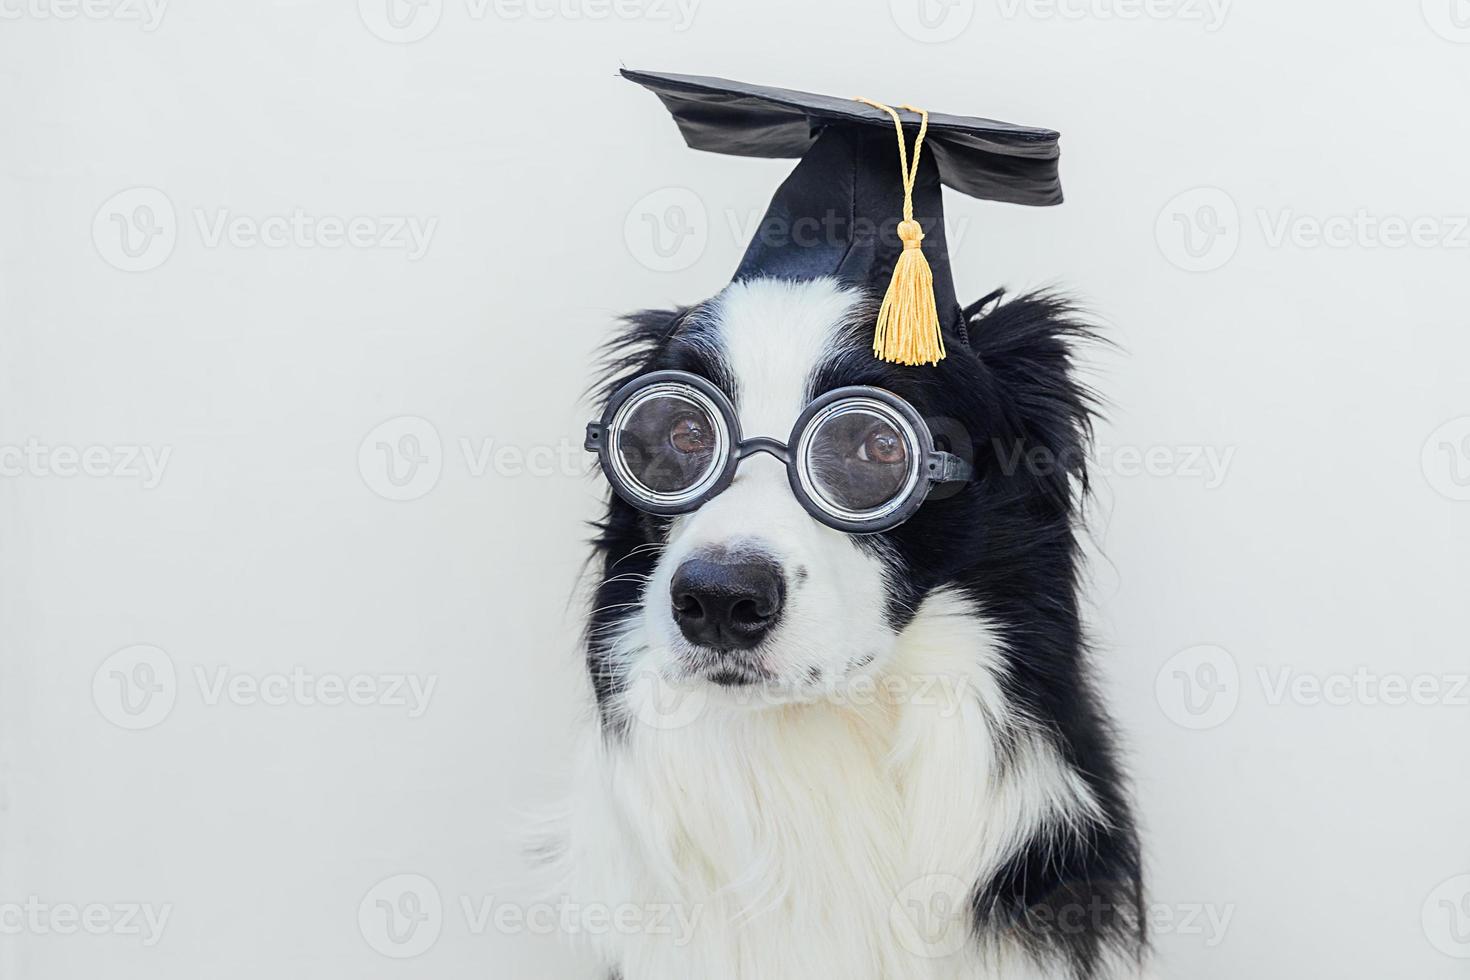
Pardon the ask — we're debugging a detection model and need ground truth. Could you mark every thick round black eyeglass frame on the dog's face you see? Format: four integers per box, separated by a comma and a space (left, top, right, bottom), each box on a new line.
584, 370, 973, 535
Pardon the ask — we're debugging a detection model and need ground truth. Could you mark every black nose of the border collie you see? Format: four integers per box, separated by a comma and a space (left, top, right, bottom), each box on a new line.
669, 558, 786, 649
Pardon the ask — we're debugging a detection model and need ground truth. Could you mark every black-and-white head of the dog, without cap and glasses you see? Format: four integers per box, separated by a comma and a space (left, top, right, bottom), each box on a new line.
589, 279, 1088, 728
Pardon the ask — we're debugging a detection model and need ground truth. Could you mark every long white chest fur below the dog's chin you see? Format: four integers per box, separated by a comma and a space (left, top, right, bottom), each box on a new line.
557, 594, 1094, 980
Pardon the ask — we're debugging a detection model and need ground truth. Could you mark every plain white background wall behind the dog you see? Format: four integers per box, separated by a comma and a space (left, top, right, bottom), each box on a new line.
0, 0, 1470, 980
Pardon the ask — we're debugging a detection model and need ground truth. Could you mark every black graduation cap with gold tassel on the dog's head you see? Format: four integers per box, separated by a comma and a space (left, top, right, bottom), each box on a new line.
623, 69, 1061, 364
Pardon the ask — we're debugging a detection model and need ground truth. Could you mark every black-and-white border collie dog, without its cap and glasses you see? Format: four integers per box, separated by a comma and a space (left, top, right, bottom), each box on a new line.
544, 279, 1145, 980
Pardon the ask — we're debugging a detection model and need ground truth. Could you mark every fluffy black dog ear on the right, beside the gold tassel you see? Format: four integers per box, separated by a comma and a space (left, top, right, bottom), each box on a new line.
964, 289, 1097, 507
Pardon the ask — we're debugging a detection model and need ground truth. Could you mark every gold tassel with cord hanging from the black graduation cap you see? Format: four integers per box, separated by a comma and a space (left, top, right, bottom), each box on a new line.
857, 98, 944, 364
